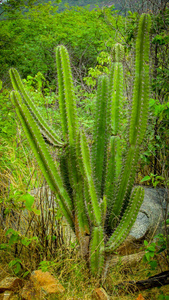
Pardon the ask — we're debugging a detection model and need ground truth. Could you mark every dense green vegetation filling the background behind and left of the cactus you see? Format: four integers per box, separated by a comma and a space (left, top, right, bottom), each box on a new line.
0, 1, 169, 299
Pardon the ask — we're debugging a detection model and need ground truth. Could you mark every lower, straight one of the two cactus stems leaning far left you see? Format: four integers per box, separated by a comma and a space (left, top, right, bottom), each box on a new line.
11, 91, 74, 228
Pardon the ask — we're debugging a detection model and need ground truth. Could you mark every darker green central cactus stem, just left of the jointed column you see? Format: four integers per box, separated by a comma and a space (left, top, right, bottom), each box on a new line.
92, 76, 110, 199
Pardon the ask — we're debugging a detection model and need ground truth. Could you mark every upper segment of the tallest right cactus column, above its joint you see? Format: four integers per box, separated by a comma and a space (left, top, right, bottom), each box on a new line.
129, 14, 151, 145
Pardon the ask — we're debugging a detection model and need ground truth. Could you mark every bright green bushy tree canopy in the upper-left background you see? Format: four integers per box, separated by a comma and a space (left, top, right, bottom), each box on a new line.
0, 3, 122, 85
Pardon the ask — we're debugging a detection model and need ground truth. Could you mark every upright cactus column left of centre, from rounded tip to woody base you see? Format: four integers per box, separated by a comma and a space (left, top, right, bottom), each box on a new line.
56, 46, 90, 254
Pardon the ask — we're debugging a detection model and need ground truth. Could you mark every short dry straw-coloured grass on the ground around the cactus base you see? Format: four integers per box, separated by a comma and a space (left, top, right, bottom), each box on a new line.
0, 229, 169, 300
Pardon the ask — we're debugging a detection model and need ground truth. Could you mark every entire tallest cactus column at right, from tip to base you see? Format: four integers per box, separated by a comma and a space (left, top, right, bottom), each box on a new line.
106, 14, 151, 244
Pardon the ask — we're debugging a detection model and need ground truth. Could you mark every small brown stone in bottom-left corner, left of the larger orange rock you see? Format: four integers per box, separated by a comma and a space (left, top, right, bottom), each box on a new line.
0, 277, 23, 293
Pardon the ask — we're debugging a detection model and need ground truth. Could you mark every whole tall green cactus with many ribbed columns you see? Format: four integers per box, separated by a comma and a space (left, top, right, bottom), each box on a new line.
10, 14, 151, 276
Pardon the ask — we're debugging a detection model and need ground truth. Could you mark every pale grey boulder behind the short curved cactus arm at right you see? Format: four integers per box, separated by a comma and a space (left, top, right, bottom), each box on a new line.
129, 187, 167, 240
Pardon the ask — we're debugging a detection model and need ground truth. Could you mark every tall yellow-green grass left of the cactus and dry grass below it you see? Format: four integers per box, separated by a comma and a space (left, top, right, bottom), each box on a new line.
0, 88, 169, 300
